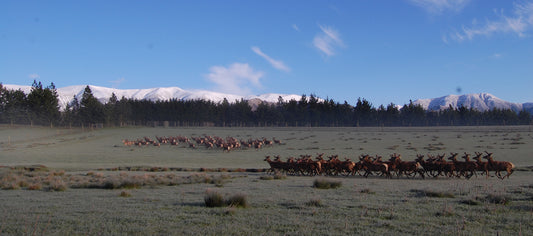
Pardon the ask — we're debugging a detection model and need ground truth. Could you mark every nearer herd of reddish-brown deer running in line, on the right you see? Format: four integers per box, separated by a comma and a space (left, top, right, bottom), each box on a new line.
265, 151, 515, 179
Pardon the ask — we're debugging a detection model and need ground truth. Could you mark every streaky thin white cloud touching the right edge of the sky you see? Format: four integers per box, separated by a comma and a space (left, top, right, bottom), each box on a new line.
443, 2, 533, 43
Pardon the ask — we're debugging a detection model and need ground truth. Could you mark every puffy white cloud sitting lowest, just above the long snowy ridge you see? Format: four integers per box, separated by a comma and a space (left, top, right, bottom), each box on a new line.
206, 63, 264, 95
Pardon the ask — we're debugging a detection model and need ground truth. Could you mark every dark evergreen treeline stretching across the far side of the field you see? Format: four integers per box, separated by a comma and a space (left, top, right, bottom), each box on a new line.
0, 81, 532, 127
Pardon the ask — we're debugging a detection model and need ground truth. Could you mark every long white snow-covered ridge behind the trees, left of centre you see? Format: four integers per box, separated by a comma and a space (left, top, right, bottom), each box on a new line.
3, 84, 301, 110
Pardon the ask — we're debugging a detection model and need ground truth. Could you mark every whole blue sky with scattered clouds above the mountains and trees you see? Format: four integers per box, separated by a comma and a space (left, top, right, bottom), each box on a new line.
0, 0, 533, 107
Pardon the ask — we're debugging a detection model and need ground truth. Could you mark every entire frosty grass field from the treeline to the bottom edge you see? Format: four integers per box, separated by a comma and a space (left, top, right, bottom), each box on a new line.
0, 126, 533, 235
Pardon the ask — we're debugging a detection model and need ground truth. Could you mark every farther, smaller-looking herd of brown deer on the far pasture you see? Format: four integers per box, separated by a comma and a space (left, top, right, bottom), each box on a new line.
122, 135, 281, 152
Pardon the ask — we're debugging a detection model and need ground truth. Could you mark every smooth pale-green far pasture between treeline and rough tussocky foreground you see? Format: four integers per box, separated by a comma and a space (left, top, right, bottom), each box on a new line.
0, 126, 533, 170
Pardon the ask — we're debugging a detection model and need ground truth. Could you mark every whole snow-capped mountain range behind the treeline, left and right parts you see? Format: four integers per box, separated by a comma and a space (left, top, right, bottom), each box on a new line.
3, 84, 533, 114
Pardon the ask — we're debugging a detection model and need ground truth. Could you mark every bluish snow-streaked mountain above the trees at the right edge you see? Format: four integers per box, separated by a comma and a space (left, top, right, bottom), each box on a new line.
413, 93, 533, 114
